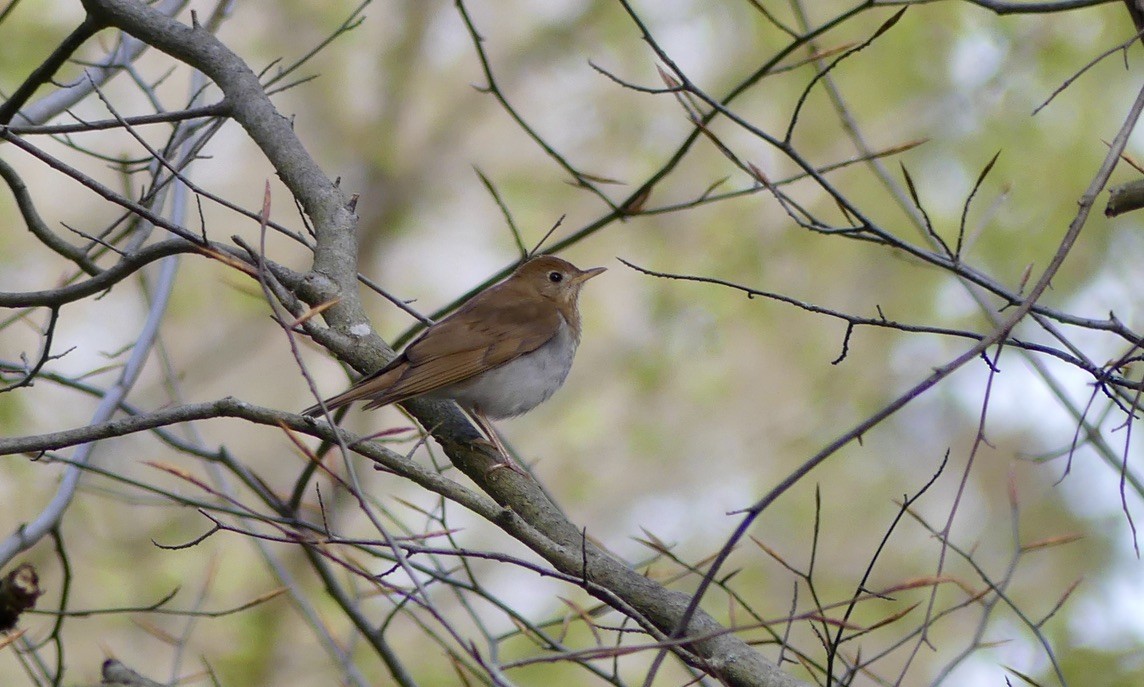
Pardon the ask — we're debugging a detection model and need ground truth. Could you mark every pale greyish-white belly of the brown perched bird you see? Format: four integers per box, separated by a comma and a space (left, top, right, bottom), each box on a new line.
432, 325, 577, 420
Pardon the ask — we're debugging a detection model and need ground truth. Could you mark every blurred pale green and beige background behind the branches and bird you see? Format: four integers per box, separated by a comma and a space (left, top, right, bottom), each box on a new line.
0, 0, 1144, 686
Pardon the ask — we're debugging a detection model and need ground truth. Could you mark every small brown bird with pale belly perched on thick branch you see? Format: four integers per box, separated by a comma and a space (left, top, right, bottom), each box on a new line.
302, 255, 606, 472
